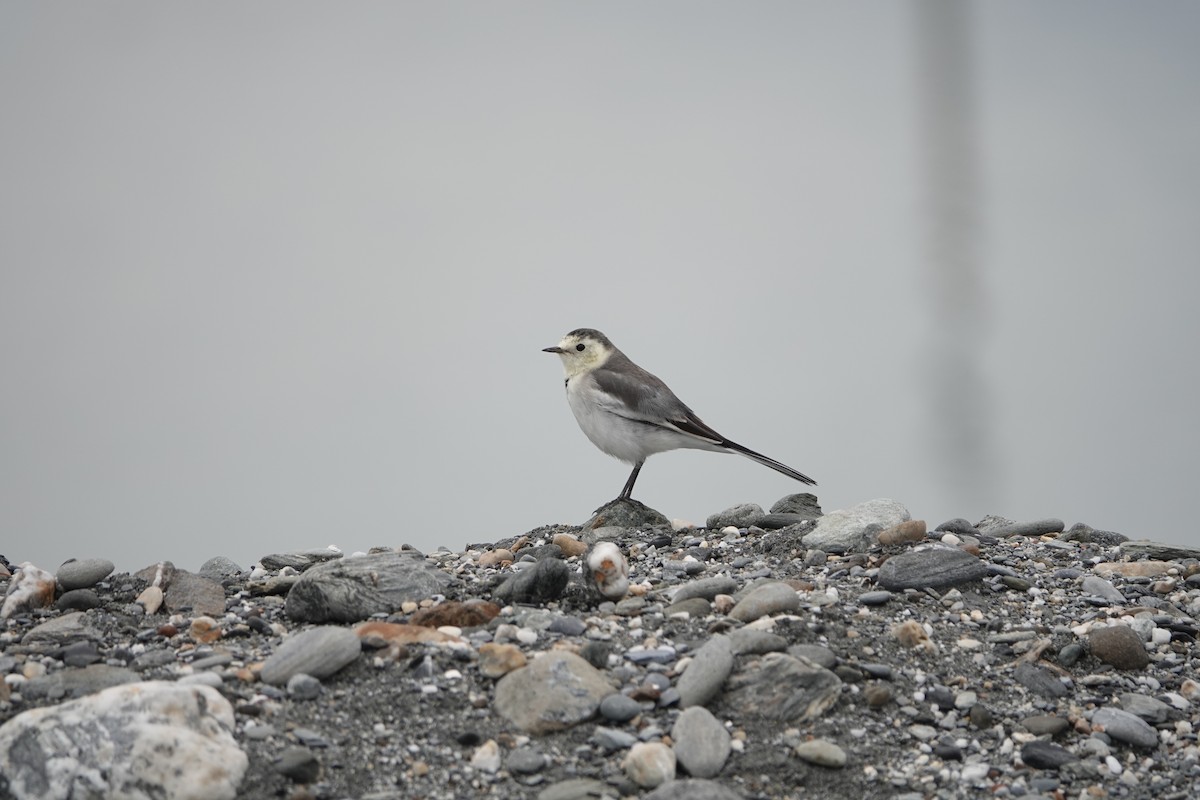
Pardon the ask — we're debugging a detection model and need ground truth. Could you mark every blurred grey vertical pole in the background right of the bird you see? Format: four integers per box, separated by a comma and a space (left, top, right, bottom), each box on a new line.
914, 0, 1002, 516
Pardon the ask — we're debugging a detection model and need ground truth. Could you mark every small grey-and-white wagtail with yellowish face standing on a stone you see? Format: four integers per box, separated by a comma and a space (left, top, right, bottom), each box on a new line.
544, 327, 816, 500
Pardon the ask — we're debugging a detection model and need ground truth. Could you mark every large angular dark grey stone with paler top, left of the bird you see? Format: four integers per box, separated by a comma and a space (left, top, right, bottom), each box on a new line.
283, 552, 454, 622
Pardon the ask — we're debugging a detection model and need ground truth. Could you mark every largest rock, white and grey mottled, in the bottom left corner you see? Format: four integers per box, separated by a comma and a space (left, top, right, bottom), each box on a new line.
0, 681, 248, 800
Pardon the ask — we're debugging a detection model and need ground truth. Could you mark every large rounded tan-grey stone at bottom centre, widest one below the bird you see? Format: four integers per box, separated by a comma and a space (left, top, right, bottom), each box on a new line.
492, 651, 613, 734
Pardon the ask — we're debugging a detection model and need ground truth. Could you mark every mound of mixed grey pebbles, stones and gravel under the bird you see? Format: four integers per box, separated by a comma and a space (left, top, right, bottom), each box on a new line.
0, 494, 1200, 800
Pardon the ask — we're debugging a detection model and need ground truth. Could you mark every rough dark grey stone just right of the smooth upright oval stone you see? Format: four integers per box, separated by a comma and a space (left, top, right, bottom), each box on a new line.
722, 652, 841, 723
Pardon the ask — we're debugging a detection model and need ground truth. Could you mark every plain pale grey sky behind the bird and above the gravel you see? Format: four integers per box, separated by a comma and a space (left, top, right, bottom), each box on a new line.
0, 1, 1200, 570
